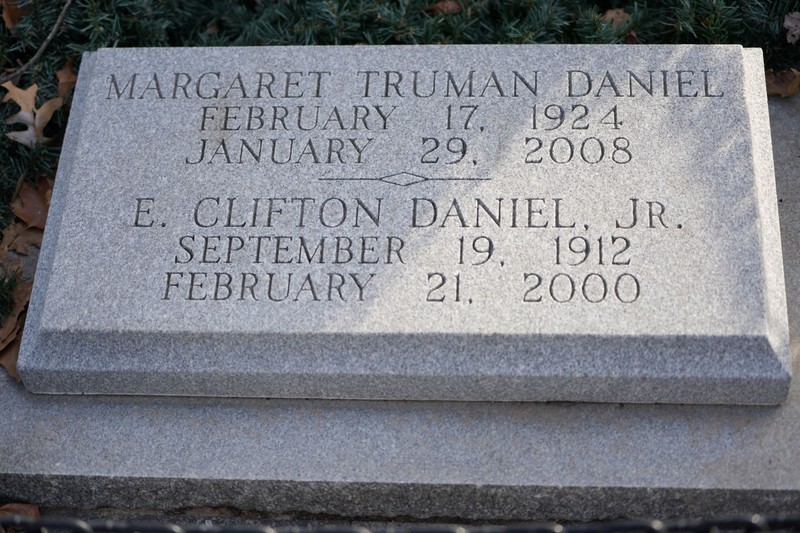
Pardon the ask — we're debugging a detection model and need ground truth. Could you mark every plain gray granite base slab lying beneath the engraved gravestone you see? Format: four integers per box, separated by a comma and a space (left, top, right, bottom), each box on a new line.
0, 45, 800, 521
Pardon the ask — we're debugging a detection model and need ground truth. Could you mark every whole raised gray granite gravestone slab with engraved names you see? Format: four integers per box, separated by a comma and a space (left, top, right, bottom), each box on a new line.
19, 46, 791, 404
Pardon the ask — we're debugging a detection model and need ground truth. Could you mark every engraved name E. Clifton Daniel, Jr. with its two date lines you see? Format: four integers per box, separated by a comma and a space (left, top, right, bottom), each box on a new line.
133, 193, 683, 304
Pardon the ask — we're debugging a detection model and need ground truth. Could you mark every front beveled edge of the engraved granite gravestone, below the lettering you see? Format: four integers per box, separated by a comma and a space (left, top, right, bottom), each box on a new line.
17, 333, 790, 405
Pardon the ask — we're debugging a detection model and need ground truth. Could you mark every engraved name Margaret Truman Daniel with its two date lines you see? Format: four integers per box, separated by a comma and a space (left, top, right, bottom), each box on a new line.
105, 69, 725, 166
